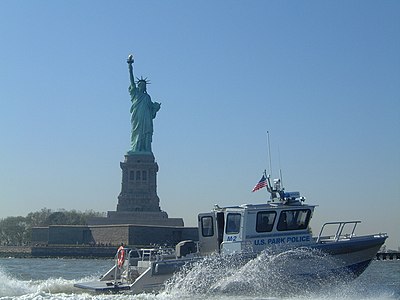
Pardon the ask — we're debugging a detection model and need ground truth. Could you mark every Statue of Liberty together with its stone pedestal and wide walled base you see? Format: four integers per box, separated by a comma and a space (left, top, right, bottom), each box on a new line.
32, 55, 198, 251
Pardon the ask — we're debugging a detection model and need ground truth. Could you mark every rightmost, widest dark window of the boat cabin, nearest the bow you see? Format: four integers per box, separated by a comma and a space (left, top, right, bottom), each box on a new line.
277, 209, 311, 231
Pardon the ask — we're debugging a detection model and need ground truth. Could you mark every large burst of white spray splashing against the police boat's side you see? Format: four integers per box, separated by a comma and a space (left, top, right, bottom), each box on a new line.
163, 249, 351, 298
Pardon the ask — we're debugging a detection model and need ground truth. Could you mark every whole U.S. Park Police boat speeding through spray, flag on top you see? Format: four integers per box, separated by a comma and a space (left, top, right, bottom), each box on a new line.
74, 175, 388, 294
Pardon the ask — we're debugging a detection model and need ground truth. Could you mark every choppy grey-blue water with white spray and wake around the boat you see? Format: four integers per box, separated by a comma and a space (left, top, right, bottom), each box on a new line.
0, 252, 400, 300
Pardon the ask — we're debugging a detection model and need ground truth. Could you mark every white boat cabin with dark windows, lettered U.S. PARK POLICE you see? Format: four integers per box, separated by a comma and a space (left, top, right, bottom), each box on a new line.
198, 192, 315, 254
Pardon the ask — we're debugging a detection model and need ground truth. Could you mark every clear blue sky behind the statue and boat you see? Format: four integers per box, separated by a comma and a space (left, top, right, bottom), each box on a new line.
0, 0, 400, 248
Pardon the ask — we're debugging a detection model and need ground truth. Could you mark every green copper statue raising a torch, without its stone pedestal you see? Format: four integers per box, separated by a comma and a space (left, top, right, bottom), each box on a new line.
127, 54, 161, 155
